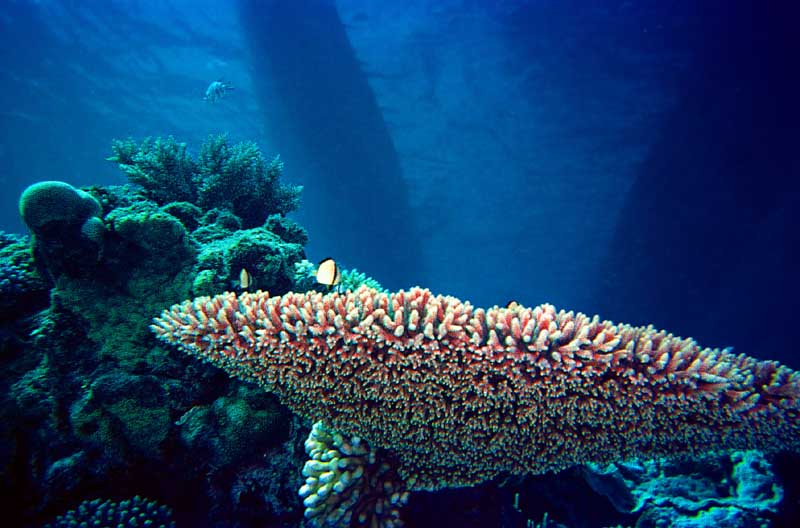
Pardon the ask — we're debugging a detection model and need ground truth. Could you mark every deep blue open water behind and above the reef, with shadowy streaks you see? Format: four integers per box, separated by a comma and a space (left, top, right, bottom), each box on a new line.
0, 0, 800, 528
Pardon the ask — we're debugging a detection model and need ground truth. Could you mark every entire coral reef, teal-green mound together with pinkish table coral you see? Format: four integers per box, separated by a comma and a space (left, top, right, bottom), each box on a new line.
0, 133, 797, 528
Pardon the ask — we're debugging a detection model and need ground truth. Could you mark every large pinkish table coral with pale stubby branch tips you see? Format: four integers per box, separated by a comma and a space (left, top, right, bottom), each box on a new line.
152, 287, 800, 489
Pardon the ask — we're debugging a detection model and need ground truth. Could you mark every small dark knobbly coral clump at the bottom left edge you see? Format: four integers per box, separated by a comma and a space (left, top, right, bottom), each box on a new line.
44, 495, 175, 528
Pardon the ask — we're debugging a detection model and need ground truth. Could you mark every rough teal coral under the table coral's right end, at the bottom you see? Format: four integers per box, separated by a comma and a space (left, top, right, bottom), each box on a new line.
584, 450, 783, 528
